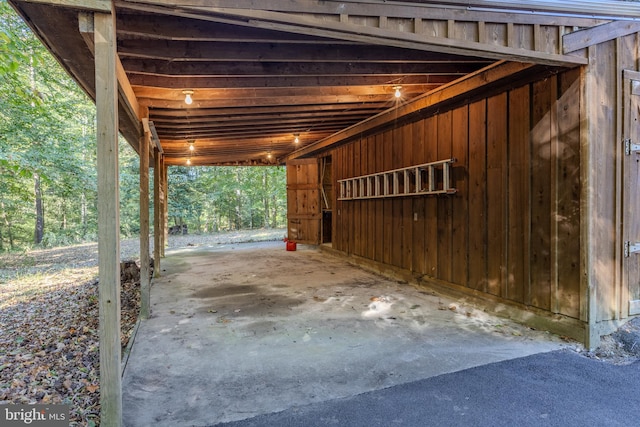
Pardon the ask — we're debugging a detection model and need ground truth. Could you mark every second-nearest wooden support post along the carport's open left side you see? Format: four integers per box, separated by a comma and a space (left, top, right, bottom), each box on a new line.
140, 125, 151, 319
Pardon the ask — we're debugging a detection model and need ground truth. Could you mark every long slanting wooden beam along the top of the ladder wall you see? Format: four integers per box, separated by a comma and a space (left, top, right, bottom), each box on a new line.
287, 62, 535, 160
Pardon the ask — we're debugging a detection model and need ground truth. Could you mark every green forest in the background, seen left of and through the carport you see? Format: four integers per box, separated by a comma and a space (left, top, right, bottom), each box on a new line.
0, 0, 286, 252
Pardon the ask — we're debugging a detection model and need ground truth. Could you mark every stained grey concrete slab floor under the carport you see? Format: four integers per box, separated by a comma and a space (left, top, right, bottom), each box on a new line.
123, 242, 564, 427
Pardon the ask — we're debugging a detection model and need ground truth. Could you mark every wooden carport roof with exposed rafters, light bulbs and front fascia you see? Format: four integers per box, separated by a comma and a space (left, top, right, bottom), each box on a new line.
10, 0, 638, 164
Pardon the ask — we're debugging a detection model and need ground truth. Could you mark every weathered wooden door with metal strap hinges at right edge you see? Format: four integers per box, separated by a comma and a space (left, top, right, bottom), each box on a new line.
622, 71, 640, 315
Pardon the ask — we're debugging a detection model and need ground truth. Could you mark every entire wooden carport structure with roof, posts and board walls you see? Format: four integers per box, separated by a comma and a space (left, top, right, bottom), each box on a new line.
10, 0, 640, 425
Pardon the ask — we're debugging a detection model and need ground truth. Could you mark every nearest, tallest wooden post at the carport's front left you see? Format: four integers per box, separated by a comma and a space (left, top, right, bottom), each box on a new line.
94, 13, 122, 426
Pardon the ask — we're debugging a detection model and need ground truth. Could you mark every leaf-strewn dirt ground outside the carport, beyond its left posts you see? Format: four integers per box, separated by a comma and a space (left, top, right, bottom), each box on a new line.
0, 229, 284, 427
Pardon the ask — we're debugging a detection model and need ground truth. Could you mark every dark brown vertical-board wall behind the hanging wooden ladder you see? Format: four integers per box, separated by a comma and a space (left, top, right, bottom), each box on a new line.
331, 69, 581, 318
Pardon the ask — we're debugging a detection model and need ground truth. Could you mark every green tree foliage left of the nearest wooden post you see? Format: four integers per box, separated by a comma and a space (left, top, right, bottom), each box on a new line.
0, 1, 97, 250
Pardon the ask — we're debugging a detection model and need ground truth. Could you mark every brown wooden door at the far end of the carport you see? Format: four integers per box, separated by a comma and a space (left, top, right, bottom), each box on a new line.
287, 159, 322, 245
